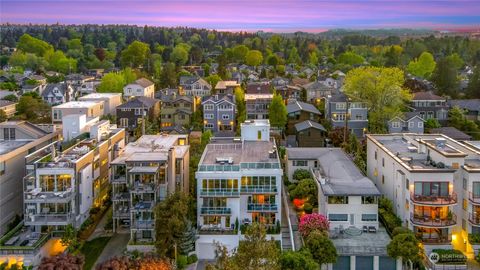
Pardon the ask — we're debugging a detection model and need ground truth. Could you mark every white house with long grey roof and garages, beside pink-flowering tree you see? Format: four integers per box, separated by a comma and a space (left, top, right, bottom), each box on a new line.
286, 147, 401, 270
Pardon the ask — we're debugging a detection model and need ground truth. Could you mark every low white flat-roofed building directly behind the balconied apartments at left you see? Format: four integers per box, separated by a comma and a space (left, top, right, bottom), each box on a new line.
52, 101, 104, 123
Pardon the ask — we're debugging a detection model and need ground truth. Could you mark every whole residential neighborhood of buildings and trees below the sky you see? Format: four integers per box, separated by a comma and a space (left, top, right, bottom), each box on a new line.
0, 9, 480, 270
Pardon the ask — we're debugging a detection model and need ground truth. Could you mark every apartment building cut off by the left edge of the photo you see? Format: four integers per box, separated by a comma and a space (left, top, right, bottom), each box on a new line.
0, 121, 58, 235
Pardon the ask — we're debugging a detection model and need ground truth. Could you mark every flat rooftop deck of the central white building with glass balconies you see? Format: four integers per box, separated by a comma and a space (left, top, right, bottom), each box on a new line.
200, 138, 279, 165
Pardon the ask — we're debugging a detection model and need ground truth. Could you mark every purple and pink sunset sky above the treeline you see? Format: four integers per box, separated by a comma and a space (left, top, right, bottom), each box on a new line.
0, 0, 480, 32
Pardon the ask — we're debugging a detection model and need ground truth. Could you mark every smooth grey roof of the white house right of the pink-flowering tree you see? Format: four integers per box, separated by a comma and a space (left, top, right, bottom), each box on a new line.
306, 148, 381, 196
